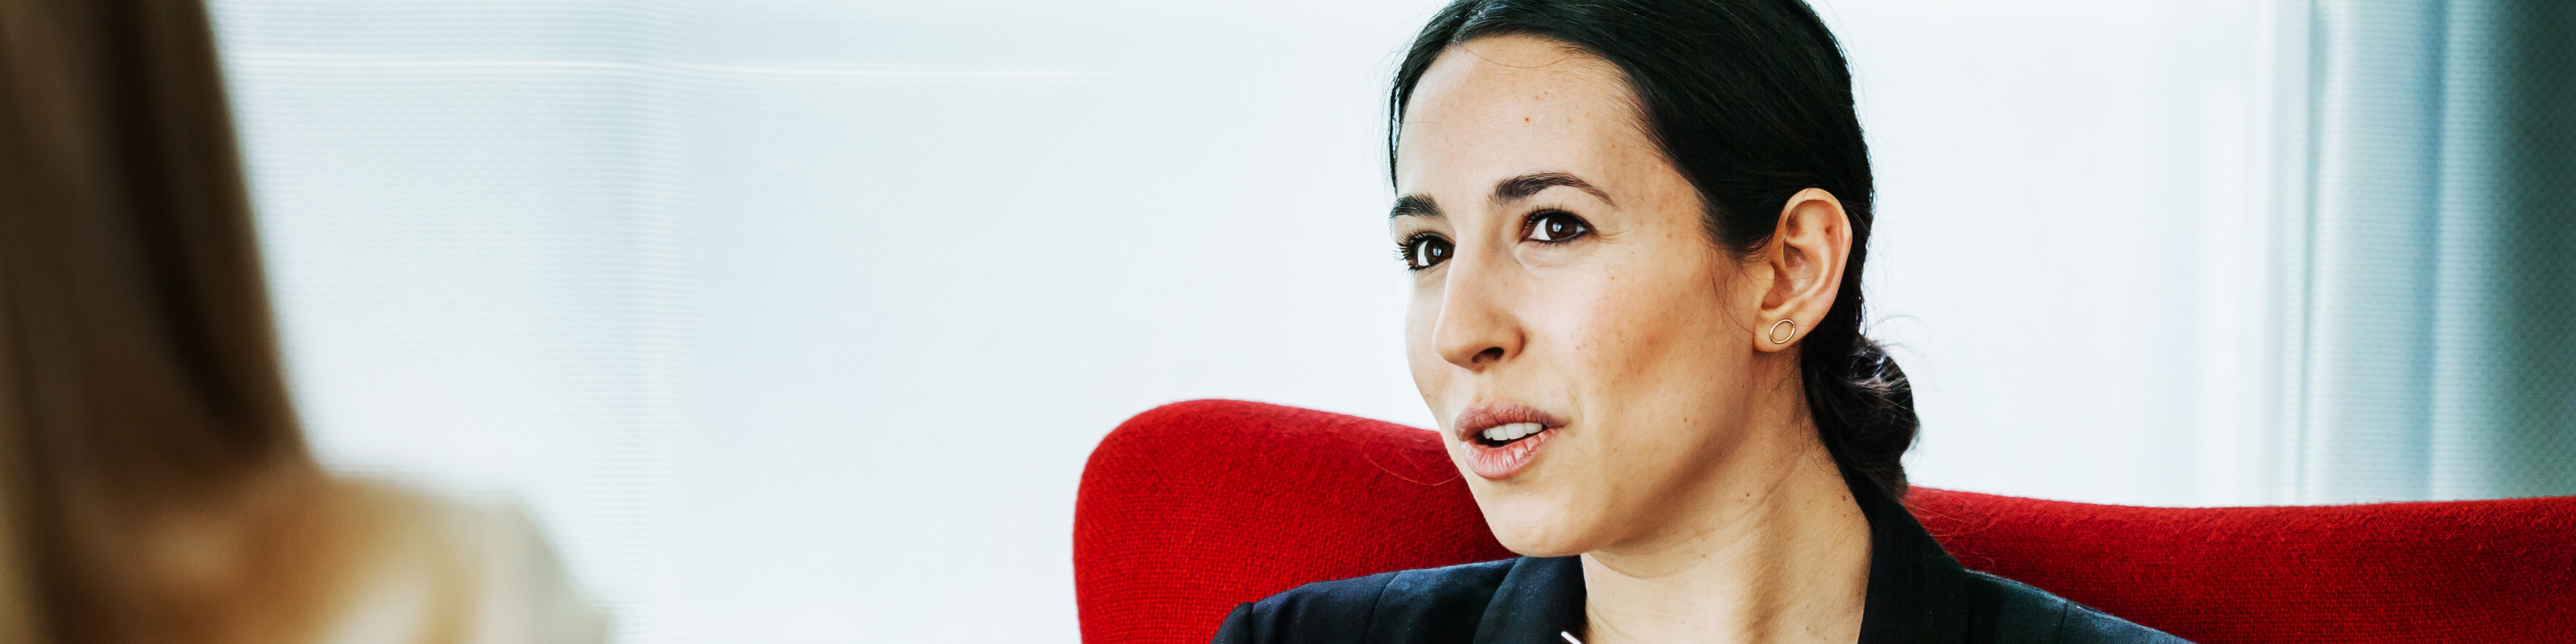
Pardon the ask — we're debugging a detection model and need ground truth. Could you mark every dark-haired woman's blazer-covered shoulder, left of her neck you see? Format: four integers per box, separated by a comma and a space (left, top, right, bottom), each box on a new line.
1216, 559, 1520, 644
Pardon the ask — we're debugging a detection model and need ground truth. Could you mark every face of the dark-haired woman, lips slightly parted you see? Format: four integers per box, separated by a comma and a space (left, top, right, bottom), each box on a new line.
1391, 36, 1778, 556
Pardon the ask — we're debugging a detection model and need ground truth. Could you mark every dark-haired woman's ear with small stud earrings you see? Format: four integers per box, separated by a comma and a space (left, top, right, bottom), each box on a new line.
1749, 188, 1852, 350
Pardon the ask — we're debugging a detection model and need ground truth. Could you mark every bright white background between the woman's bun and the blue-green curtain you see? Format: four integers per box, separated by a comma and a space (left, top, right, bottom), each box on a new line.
1819, 0, 2285, 505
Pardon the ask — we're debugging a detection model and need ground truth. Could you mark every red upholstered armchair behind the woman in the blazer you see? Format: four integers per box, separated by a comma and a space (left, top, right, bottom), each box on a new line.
1074, 399, 2576, 644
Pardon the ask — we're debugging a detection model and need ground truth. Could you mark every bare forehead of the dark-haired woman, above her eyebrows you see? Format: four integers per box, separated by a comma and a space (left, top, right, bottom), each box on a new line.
1396, 36, 1662, 193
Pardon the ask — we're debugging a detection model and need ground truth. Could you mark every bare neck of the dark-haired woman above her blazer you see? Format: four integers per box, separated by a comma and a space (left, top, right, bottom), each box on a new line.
1582, 423, 1870, 644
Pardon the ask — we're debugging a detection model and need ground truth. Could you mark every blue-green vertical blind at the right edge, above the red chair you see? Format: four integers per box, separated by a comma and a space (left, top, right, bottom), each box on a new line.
2279, 0, 2576, 502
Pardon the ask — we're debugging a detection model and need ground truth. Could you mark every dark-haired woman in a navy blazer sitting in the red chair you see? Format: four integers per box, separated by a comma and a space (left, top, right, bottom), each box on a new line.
1216, 0, 2177, 644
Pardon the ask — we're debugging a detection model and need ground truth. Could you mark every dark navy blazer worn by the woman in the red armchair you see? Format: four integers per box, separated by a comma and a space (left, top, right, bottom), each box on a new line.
1216, 484, 2187, 644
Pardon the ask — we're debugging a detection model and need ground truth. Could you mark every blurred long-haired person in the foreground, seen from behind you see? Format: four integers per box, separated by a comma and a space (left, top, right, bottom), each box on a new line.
0, 0, 605, 644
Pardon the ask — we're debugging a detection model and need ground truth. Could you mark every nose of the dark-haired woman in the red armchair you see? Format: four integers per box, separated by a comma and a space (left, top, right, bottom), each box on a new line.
1432, 252, 1527, 374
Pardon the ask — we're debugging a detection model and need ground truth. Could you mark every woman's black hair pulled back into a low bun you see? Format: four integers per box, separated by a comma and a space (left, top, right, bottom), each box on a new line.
1386, 0, 1919, 500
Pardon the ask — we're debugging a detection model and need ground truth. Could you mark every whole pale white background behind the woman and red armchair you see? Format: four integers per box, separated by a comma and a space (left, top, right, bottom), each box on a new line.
214, 0, 2555, 644
